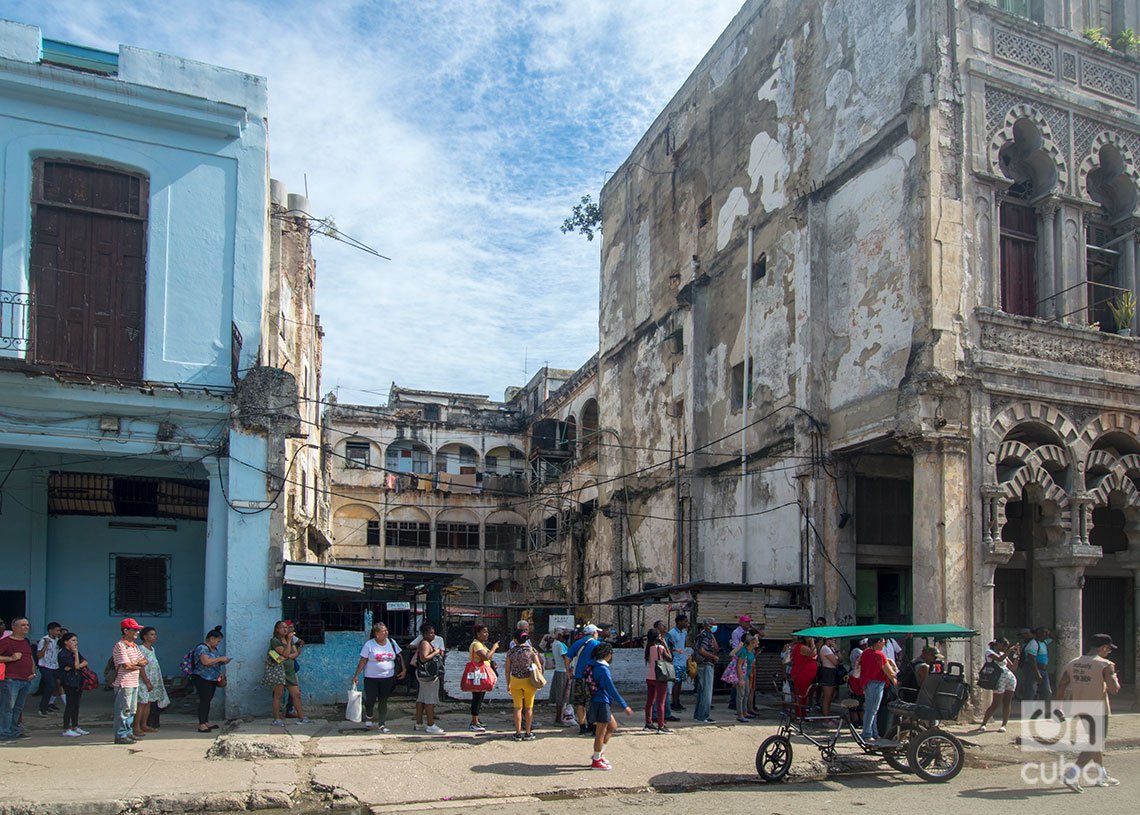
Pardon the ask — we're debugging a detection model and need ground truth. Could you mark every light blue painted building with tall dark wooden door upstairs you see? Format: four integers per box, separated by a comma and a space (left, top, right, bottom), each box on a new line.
0, 21, 296, 714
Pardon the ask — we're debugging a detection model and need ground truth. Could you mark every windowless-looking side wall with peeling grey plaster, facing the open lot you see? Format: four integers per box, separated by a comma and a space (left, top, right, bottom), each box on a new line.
587, 0, 931, 615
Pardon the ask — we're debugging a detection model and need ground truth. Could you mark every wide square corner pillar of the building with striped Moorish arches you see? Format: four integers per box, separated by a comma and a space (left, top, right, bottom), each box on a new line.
911, 438, 971, 624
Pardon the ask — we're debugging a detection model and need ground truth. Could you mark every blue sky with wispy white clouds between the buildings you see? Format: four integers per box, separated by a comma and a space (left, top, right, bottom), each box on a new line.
13, 0, 741, 402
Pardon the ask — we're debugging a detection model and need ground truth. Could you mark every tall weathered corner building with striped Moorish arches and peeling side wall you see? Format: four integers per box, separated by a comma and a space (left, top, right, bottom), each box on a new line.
587, 0, 1140, 680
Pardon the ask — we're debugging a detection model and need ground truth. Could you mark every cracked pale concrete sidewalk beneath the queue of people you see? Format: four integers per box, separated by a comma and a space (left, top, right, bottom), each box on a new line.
0, 699, 1140, 815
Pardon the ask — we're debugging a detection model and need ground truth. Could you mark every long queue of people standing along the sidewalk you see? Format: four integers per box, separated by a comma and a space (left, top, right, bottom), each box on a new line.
0, 613, 1119, 792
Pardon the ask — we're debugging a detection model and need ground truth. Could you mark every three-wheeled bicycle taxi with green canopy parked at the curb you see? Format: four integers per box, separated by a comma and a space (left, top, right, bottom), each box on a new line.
756, 624, 978, 782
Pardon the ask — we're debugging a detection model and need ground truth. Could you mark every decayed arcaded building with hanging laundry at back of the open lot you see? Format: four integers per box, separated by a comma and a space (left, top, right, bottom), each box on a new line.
325, 360, 597, 633
